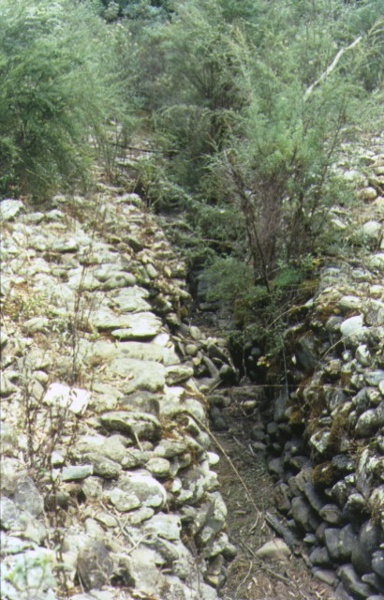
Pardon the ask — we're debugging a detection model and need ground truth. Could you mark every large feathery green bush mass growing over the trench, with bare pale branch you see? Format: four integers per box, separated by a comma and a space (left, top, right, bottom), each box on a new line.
116, 0, 384, 352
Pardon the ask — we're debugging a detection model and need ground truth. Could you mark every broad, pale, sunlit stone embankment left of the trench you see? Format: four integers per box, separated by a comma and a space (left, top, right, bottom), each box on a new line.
0, 186, 236, 600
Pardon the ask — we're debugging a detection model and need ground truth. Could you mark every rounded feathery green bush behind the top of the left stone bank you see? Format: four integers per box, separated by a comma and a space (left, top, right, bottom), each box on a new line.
0, 0, 124, 196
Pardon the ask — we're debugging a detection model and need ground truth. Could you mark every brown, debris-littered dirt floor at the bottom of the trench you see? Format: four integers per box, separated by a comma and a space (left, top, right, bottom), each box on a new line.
214, 392, 335, 600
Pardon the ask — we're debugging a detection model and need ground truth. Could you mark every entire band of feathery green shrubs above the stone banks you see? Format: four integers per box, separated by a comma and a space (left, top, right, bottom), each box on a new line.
0, 0, 384, 354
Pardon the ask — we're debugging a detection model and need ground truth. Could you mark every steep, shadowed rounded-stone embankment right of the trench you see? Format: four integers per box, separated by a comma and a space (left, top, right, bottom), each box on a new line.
254, 146, 384, 600
